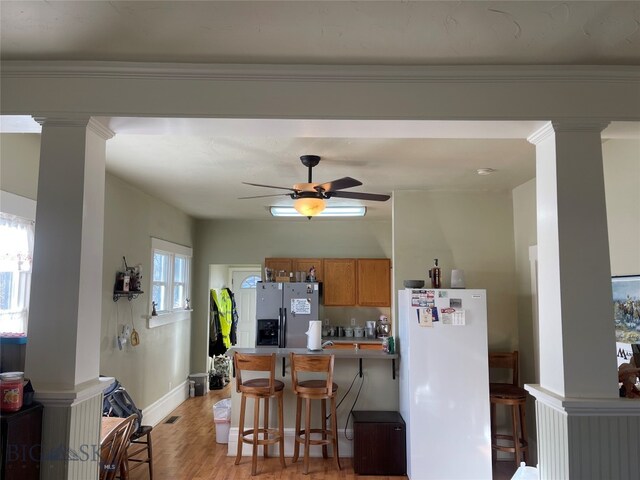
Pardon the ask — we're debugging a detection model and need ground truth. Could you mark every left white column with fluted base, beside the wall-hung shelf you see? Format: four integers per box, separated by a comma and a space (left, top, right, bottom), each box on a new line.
25, 117, 113, 479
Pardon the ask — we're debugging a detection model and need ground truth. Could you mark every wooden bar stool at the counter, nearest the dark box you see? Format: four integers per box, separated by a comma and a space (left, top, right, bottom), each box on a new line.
291, 353, 340, 475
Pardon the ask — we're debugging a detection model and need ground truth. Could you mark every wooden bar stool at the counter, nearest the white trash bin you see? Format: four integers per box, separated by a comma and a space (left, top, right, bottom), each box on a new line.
233, 352, 286, 475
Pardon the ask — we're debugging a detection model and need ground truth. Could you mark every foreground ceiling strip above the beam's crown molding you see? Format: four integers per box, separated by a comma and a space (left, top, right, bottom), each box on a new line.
0, 0, 640, 65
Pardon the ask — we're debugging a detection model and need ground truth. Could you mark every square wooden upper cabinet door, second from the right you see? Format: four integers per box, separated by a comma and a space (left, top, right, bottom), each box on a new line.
323, 258, 357, 306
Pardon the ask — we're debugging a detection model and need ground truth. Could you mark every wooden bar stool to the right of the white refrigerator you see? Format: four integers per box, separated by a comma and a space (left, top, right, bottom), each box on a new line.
489, 351, 529, 466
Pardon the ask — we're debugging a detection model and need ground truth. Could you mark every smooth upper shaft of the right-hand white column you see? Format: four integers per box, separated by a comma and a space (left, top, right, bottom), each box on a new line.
529, 122, 618, 398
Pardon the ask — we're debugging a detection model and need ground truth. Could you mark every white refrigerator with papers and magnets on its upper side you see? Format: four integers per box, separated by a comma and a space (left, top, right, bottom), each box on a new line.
397, 289, 492, 480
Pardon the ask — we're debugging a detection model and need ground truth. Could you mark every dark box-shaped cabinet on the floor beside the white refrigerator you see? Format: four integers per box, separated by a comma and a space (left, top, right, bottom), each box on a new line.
352, 411, 407, 475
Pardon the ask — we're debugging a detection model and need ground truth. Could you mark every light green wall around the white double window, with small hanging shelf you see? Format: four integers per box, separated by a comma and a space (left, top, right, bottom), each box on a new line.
100, 175, 194, 408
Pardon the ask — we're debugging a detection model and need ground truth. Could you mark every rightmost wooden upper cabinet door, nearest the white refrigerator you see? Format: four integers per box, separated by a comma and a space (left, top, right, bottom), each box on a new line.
358, 258, 391, 307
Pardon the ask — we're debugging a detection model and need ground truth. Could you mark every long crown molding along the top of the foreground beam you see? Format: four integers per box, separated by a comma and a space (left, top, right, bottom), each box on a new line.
0, 60, 640, 83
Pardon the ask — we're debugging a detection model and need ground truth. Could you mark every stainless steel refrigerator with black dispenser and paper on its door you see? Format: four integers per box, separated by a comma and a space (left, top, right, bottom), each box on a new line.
256, 282, 320, 348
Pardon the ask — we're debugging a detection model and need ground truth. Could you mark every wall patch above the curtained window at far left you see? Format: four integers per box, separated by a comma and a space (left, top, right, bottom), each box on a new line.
0, 133, 40, 200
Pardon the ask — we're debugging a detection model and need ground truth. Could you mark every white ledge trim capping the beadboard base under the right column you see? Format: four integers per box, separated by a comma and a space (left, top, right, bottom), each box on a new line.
524, 384, 640, 417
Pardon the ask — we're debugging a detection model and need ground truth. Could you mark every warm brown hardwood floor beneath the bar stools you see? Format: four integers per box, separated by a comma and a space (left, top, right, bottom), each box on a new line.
130, 385, 515, 480
